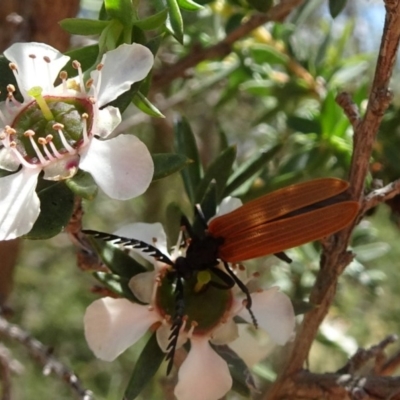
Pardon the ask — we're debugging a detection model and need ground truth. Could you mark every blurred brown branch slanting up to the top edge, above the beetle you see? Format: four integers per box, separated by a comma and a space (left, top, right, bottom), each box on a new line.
152, 0, 304, 90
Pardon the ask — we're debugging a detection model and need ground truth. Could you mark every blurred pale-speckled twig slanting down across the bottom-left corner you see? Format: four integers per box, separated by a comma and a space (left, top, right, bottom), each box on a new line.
0, 316, 94, 400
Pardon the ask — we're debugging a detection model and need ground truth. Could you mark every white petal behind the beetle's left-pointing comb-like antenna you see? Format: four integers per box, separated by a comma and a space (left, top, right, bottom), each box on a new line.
114, 222, 169, 263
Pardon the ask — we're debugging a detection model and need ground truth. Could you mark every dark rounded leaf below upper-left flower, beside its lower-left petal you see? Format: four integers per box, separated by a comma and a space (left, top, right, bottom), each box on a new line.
24, 182, 74, 239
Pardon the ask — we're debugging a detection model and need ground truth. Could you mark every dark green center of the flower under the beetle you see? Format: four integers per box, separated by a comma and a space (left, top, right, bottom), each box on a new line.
155, 273, 233, 334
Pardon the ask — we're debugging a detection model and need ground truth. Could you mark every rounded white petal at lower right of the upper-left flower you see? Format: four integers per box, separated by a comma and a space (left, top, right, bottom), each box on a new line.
79, 135, 154, 200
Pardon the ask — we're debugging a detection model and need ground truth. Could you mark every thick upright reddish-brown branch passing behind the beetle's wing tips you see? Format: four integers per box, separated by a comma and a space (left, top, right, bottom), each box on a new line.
266, 0, 400, 399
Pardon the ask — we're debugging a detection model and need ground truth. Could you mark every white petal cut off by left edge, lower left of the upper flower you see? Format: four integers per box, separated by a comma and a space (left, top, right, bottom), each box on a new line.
0, 168, 40, 240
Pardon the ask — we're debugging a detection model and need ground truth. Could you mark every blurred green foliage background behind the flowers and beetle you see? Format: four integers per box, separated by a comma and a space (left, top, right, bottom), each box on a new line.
0, 0, 400, 400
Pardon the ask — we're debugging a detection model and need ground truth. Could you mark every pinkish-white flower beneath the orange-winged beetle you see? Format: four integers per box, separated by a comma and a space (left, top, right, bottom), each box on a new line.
84, 205, 295, 400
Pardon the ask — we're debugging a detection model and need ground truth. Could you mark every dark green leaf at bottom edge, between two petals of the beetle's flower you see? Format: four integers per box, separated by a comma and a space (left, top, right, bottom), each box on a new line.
123, 333, 165, 400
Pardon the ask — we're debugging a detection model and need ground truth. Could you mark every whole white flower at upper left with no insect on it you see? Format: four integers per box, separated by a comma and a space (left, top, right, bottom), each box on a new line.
0, 43, 154, 240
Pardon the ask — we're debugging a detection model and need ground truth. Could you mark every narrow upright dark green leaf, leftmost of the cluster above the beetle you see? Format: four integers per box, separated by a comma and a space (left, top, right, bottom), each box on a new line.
175, 118, 202, 204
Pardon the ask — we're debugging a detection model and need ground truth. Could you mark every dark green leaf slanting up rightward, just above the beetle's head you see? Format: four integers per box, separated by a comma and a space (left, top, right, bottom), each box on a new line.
196, 146, 236, 203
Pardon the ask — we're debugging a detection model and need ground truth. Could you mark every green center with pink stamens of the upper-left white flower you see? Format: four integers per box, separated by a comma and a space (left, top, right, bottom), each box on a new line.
0, 94, 93, 167
